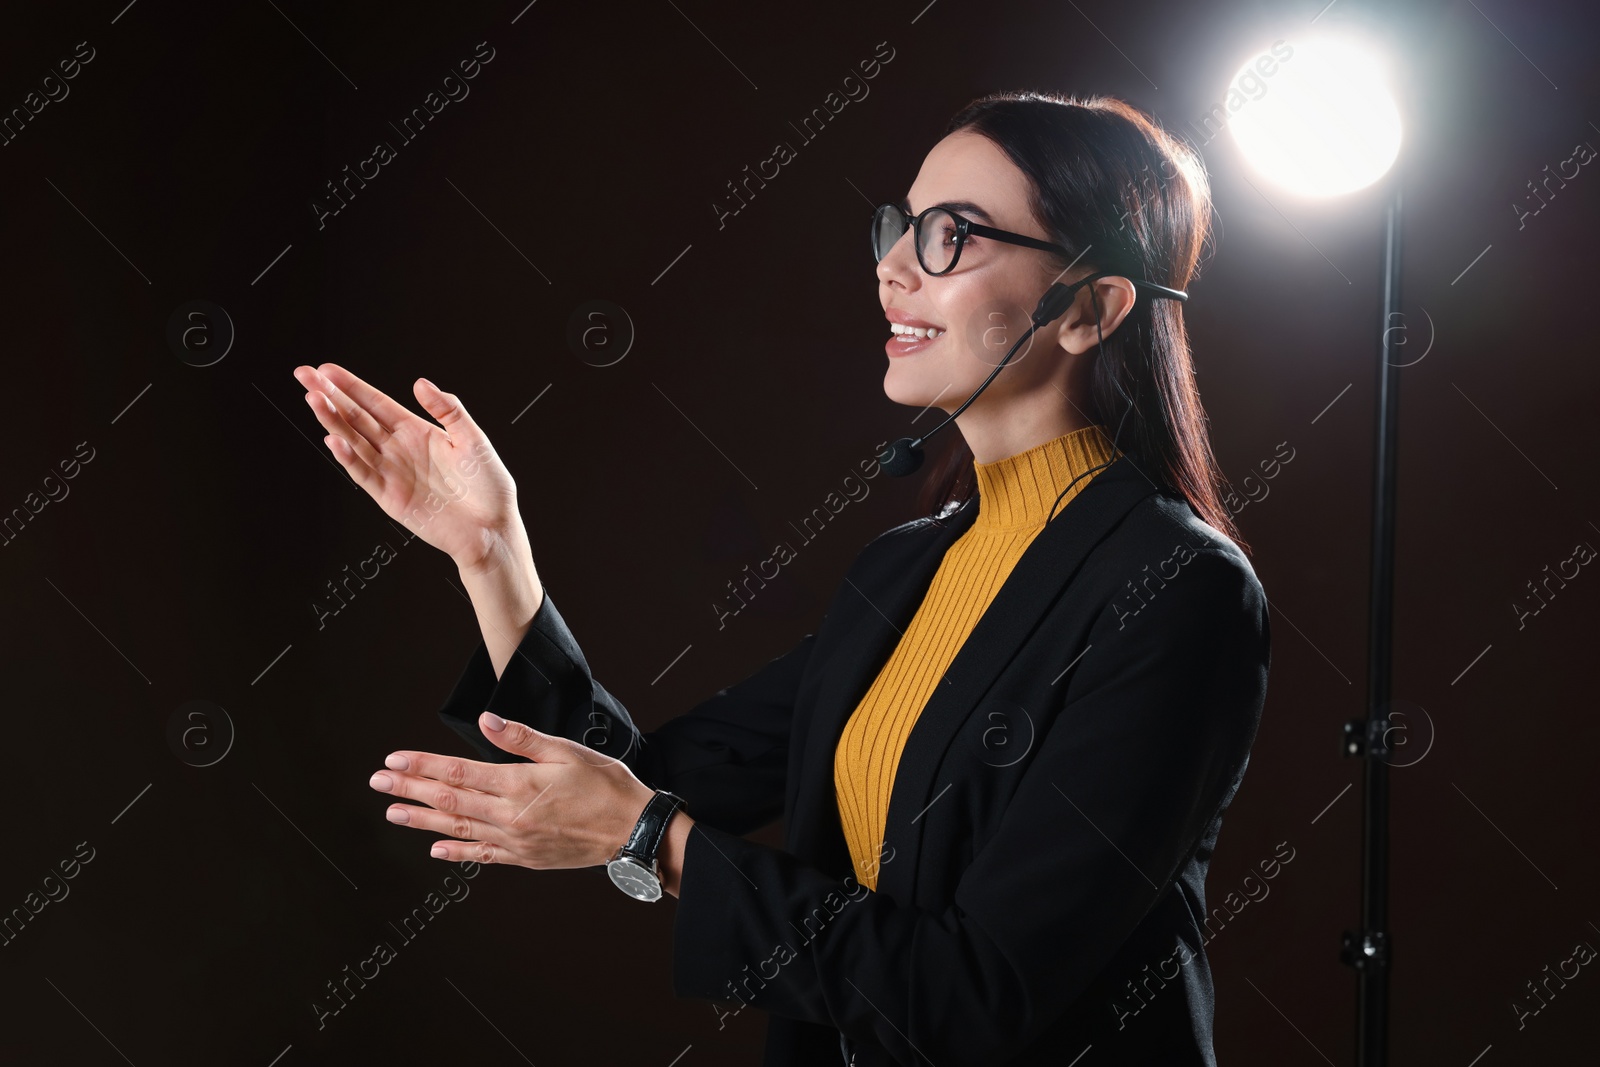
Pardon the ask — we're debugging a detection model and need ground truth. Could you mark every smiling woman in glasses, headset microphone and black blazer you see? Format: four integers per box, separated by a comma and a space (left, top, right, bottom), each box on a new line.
294, 93, 1269, 1067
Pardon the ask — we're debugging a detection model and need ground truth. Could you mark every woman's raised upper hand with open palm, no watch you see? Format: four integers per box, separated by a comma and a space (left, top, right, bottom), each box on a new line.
294, 363, 526, 571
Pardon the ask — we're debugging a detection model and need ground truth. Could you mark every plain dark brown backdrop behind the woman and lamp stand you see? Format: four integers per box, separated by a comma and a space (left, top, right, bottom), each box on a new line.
0, 0, 1600, 1067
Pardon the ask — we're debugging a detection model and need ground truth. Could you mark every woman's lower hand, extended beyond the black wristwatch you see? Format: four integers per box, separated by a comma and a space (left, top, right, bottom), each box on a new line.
371, 712, 654, 869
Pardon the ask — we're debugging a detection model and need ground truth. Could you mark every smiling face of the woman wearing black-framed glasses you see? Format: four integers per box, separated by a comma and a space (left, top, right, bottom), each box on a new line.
878, 130, 1086, 419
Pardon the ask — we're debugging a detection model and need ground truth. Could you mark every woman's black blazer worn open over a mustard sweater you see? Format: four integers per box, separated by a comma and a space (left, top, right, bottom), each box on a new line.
440, 456, 1269, 1067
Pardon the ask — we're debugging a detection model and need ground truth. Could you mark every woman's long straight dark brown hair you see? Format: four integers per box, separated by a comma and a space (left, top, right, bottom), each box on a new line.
920, 91, 1250, 552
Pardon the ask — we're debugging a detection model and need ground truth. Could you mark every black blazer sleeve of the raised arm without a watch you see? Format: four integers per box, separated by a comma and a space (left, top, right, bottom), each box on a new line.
438, 589, 814, 833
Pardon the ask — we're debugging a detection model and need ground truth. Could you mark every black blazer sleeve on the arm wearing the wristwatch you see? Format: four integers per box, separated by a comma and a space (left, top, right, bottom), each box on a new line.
672, 553, 1269, 1067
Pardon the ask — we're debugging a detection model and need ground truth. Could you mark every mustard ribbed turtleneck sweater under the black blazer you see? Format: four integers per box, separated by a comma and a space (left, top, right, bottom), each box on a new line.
834, 426, 1112, 889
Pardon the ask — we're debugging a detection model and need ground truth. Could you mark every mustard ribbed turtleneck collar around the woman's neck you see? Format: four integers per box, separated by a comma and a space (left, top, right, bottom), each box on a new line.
973, 426, 1114, 531
